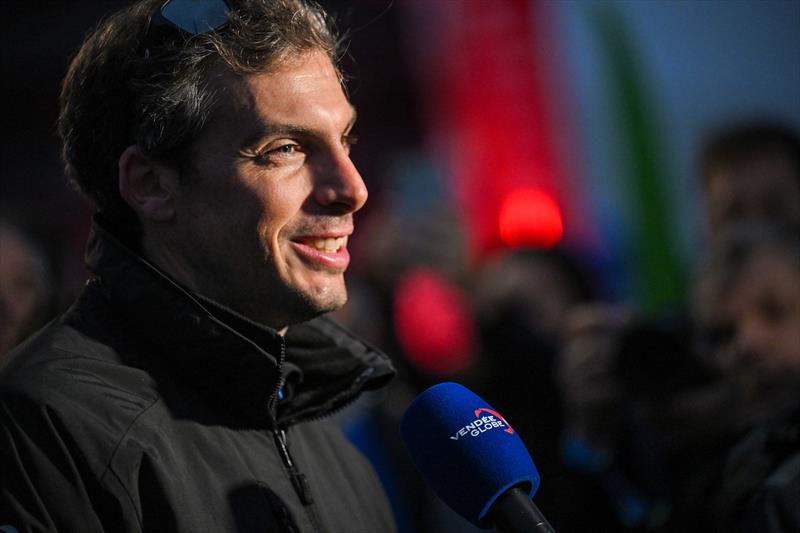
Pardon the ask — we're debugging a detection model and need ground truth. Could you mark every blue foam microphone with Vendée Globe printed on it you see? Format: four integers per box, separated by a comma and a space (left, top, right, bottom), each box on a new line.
400, 383, 554, 533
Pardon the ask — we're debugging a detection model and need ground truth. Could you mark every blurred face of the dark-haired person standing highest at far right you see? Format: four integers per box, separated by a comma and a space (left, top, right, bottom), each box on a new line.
706, 153, 800, 238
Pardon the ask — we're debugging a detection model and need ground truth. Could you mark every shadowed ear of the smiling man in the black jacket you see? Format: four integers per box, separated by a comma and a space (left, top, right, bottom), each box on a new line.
119, 145, 180, 222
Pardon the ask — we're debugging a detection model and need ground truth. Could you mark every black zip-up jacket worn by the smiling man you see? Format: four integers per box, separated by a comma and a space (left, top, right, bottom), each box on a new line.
0, 218, 394, 533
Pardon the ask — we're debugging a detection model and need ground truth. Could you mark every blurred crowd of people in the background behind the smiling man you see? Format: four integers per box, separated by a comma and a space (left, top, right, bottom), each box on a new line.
0, 114, 800, 533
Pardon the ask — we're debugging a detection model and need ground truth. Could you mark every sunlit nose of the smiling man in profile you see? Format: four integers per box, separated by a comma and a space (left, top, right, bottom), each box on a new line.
314, 149, 368, 213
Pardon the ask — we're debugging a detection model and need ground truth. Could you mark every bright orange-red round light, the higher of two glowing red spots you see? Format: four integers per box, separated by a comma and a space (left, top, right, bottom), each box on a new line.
498, 188, 564, 248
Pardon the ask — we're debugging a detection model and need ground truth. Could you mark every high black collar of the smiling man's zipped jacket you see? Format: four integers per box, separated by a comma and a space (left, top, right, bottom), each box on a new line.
81, 217, 394, 425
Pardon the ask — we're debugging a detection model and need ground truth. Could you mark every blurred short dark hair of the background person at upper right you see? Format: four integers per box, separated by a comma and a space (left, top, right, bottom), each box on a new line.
699, 120, 800, 185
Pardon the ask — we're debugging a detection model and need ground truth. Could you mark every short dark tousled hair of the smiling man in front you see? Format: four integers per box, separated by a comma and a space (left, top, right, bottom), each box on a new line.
58, 0, 341, 237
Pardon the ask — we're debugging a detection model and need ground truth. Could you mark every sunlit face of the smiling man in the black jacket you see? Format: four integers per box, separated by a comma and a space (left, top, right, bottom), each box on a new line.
172, 51, 367, 329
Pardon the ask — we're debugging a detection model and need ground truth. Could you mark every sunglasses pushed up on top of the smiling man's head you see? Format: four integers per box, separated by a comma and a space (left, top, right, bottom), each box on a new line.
144, 0, 229, 57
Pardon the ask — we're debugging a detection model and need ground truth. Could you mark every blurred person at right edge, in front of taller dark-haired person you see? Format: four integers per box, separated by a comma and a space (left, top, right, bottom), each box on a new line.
694, 225, 800, 533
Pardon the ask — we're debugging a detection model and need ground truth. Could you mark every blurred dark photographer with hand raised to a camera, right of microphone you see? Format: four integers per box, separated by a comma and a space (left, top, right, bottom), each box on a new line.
558, 308, 743, 533
